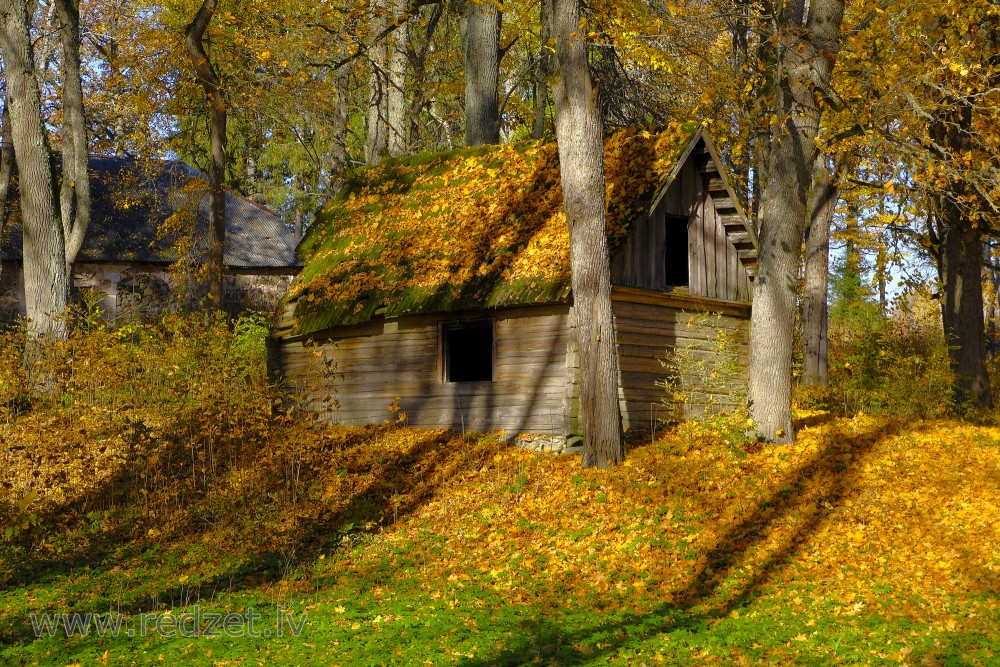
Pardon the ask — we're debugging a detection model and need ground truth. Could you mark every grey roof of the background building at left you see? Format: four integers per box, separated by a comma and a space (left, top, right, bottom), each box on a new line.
0, 156, 298, 268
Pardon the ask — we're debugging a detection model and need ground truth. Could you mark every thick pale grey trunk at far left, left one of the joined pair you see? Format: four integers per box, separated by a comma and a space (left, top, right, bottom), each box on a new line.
0, 0, 68, 338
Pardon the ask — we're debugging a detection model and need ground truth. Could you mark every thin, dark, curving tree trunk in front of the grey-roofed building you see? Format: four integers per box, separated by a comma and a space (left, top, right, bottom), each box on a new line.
184, 0, 226, 308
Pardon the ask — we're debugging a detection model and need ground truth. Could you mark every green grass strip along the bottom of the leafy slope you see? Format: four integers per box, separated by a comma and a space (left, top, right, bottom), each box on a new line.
0, 535, 1000, 666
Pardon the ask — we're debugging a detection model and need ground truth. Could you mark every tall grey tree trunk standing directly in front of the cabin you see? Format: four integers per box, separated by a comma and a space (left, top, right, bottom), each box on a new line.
552, 0, 624, 468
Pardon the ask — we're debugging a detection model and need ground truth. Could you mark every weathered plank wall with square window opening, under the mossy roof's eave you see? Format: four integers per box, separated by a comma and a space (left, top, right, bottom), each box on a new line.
273, 305, 570, 435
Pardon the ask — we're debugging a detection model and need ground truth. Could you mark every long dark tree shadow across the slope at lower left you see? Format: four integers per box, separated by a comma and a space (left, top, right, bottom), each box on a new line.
0, 427, 503, 642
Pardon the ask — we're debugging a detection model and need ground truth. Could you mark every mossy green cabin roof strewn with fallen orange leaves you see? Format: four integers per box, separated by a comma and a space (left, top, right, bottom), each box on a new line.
287, 123, 700, 334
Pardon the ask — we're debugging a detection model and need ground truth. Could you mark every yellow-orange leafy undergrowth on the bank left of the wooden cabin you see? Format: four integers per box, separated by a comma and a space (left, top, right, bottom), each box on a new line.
0, 313, 280, 540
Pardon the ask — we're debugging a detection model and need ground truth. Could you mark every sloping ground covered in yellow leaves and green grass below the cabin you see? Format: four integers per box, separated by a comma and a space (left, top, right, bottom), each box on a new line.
0, 416, 1000, 667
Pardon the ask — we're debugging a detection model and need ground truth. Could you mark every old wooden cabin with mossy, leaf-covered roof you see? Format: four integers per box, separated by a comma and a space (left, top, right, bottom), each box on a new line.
272, 125, 757, 442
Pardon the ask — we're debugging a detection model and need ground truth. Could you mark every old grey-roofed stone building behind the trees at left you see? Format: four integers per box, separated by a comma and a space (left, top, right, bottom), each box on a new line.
0, 156, 299, 321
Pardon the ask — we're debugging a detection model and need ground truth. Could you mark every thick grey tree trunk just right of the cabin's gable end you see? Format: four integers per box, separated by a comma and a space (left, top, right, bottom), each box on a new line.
748, 0, 844, 443
